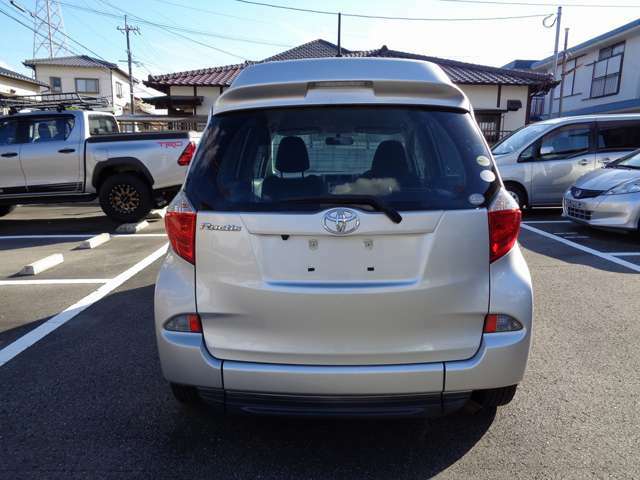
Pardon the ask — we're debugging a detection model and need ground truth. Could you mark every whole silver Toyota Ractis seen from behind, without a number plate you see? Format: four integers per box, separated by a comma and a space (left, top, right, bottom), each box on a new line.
155, 58, 532, 416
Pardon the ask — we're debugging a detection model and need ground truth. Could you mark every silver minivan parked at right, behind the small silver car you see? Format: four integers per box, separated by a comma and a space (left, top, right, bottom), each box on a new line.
492, 114, 640, 207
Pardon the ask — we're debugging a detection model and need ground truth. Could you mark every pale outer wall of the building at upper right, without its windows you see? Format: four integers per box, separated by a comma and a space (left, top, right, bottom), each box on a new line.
536, 30, 640, 115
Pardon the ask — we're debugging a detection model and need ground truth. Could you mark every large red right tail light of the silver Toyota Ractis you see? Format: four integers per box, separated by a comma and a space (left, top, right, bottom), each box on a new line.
489, 188, 522, 263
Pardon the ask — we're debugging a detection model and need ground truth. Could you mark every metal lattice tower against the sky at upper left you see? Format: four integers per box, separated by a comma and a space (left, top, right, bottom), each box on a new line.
33, 0, 67, 58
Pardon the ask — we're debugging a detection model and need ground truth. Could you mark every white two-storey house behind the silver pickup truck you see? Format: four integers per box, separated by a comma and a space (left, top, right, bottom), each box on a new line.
23, 55, 137, 115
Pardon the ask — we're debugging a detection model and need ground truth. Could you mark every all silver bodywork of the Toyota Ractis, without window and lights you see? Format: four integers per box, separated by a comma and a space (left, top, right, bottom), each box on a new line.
155, 59, 532, 404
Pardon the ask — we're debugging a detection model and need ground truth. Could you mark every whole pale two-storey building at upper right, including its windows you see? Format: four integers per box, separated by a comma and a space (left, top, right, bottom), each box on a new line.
512, 19, 640, 118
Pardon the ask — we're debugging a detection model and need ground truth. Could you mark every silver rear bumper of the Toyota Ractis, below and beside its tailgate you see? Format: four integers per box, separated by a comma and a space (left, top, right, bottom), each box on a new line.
155, 246, 533, 395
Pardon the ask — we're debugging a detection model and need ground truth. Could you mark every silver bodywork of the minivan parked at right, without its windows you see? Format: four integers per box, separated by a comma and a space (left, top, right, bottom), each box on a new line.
494, 114, 640, 206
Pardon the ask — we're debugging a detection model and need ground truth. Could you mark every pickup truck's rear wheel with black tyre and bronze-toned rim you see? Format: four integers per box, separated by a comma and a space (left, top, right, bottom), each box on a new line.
99, 173, 153, 223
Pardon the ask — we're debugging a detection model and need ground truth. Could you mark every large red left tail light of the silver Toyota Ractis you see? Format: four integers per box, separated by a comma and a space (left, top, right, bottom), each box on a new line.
164, 191, 196, 265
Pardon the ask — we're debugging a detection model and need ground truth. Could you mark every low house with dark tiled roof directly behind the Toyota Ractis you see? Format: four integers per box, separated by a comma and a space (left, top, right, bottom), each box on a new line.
144, 39, 552, 141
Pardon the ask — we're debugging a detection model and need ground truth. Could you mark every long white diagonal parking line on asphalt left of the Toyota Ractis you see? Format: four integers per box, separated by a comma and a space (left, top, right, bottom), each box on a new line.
0, 244, 169, 367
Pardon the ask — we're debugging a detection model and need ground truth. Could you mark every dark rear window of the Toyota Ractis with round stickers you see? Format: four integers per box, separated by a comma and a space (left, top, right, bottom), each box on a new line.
185, 107, 497, 211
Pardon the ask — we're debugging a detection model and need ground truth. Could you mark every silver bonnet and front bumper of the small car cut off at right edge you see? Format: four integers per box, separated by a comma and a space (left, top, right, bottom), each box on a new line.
562, 168, 640, 231
